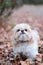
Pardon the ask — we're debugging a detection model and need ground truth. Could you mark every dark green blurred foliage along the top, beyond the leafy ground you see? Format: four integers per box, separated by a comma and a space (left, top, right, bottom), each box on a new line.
0, 0, 43, 15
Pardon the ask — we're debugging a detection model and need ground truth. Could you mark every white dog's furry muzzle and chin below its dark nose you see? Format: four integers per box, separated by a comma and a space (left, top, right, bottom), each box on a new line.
15, 34, 32, 43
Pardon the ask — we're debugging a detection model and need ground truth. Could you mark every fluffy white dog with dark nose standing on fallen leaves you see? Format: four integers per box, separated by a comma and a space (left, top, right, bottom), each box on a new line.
12, 23, 40, 60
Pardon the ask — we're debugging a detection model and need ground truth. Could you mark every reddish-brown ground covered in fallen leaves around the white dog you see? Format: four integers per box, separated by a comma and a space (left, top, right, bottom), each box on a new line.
0, 5, 43, 65
